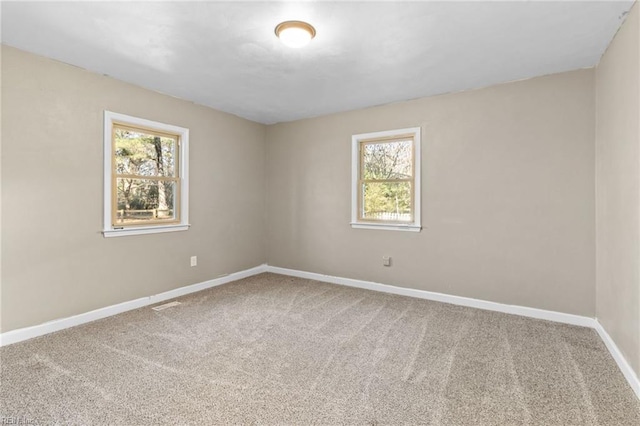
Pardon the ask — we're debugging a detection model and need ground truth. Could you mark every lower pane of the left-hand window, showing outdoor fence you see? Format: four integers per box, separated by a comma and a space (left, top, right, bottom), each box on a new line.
114, 178, 176, 224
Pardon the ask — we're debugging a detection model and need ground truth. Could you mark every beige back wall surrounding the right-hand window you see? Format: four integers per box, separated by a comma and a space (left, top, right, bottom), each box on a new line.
266, 70, 595, 316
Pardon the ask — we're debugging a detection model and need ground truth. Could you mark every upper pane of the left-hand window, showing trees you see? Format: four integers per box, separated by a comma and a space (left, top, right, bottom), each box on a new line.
114, 127, 177, 177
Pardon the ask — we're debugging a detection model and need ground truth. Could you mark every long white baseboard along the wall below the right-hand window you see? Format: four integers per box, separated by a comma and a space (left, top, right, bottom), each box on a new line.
266, 266, 596, 328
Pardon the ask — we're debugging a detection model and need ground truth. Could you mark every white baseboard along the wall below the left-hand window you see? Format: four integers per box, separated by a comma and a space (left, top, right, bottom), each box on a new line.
0, 265, 267, 346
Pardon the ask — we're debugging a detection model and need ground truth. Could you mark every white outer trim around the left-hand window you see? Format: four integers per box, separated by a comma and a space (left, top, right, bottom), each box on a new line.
102, 111, 191, 237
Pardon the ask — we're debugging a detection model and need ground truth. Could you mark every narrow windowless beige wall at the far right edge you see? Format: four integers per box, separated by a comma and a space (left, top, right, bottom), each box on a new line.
596, 4, 640, 375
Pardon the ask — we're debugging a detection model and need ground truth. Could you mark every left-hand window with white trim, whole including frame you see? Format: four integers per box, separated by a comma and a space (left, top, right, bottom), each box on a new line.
103, 111, 189, 237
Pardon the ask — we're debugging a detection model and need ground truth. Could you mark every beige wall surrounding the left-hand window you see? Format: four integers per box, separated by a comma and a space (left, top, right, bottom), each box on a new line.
1, 46, 265, 331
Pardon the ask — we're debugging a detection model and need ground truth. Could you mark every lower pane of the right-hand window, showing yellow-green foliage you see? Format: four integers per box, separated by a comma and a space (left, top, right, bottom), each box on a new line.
362, 182, 413, 222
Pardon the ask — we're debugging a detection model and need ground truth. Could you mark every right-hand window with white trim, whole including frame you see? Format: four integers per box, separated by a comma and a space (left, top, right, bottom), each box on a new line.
351, 127, 421, 232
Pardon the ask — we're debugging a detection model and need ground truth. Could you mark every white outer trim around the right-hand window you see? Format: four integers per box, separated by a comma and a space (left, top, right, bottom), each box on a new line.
351, 127, 422, 232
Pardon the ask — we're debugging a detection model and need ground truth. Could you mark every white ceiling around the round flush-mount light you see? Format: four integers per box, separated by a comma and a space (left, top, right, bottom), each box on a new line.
2, 0, 633, 124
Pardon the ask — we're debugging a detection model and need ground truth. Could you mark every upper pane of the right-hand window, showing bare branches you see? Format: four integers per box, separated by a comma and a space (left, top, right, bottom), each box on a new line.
362, 139, 413, 179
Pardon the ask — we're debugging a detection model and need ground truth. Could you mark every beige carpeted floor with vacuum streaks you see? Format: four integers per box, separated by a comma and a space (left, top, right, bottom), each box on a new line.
0, 274, 640, 425
